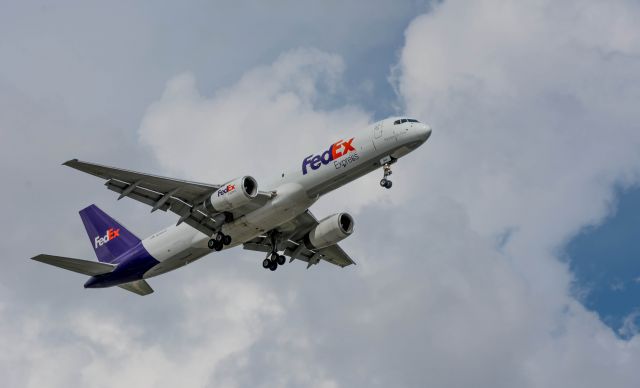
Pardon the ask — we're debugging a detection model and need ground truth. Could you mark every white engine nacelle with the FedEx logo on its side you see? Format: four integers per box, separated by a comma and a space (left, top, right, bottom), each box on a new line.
204, 176, 258, 213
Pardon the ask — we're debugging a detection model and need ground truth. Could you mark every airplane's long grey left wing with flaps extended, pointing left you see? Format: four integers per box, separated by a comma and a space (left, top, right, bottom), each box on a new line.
63, 159, 271, 236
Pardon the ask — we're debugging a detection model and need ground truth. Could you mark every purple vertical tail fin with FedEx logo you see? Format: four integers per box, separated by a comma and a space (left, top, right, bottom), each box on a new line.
80, 205, 140, 263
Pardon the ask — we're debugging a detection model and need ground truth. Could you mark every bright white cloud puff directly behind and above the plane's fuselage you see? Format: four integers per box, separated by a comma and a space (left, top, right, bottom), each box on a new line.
140, 48, 396, 212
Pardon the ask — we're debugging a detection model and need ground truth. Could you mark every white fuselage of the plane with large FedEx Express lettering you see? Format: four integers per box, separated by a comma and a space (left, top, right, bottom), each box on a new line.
142, 118, 431, 278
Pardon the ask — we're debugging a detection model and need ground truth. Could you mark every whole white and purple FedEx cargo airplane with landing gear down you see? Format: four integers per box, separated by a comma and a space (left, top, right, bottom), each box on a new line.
32, 117, 431, 295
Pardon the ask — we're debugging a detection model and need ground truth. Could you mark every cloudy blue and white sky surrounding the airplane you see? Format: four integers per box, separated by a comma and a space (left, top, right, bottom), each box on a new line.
0, 0, 640, 388
